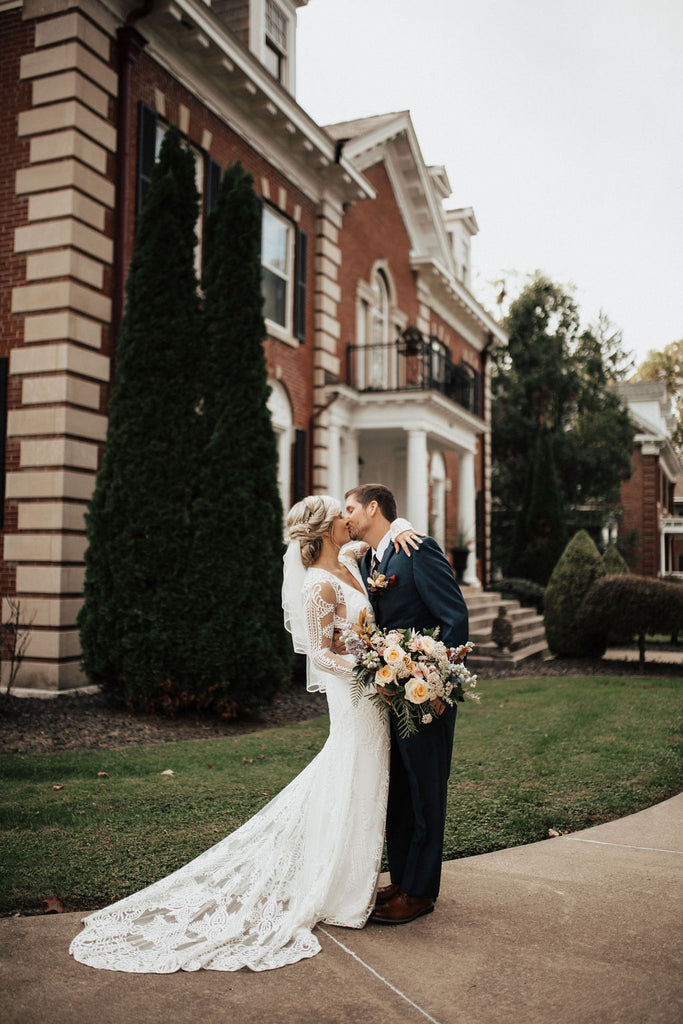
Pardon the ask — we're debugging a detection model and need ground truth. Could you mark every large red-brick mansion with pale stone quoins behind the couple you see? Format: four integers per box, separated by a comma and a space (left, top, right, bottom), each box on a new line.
0, 0, 506, 690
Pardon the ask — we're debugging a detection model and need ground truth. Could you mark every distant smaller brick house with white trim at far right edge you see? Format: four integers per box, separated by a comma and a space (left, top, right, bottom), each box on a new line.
615, 381, 683, 577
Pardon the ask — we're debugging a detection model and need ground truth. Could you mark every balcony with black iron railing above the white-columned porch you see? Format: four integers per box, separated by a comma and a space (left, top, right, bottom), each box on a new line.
346, 328, 481, 416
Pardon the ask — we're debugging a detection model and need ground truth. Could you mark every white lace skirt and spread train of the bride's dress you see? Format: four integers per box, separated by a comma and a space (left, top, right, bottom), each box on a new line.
70, 663, 389, 974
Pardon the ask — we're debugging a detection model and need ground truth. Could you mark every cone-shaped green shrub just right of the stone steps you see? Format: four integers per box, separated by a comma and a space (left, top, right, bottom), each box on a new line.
545, 529, 606, 657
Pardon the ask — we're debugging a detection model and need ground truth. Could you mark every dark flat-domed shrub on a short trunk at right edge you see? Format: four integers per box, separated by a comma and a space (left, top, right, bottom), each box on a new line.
577, 573, 683, 666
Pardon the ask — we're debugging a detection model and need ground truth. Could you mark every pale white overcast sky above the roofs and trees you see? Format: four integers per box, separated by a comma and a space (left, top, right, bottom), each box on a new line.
297, 0, 683, 361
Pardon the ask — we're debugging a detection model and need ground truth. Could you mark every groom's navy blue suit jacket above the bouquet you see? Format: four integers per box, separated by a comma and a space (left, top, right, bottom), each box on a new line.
362, 537, 468, 647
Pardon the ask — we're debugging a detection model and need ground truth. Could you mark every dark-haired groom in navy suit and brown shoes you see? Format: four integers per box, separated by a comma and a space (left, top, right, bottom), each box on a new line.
346, 483, 467, 925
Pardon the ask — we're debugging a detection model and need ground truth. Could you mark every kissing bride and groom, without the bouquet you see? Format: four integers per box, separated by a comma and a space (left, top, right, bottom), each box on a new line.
70, 483, 468, 974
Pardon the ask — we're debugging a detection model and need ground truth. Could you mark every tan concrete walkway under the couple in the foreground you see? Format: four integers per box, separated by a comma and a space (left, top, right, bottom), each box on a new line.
0, 795, 683, 1024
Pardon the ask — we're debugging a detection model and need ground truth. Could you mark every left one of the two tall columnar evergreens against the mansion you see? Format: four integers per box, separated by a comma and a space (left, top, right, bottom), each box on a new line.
79, 129, 199, 708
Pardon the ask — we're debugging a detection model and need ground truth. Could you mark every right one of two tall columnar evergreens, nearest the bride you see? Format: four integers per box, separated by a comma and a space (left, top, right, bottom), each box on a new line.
193, 164, 290, 711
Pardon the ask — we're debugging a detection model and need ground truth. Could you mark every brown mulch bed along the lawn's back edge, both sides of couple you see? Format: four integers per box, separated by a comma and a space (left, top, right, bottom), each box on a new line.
0, 647, 683, 754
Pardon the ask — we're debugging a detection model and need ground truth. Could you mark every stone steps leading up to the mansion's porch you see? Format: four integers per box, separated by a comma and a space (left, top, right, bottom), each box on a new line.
463, 587, 552, 671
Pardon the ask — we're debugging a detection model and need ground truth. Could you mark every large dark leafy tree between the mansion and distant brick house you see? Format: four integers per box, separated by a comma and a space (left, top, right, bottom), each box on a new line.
492, 274, 633, 570
